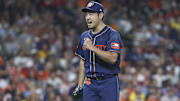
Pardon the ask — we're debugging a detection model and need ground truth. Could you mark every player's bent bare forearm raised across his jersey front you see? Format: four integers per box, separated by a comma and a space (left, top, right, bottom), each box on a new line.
92, 47, 118, 64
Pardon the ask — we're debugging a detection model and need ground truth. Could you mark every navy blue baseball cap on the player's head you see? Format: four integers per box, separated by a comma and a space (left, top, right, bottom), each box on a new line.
82, 1, 104, 13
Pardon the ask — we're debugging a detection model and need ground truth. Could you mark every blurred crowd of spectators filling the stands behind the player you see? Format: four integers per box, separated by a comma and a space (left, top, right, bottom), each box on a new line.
0, 0, 180, 101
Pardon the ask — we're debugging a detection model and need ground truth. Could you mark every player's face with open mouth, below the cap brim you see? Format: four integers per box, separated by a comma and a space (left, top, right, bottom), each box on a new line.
85, 12, 100, 29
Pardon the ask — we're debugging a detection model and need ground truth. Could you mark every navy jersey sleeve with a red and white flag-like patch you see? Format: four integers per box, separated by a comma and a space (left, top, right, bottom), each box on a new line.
107, 32, 123, 53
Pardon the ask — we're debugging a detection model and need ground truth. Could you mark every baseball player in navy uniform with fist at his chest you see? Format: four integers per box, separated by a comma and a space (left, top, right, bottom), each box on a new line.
73, 1, 122, 101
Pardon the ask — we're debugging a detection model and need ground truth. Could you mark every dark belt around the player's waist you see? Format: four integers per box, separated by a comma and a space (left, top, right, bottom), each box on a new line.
86, 74, 118, 80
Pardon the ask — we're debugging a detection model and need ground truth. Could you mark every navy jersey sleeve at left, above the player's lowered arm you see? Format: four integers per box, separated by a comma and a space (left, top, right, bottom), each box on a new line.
75, 37, 85, 60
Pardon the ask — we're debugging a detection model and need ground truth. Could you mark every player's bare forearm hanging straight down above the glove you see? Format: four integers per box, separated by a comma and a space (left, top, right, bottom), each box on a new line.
78, 59, 85, 87
